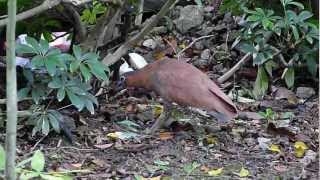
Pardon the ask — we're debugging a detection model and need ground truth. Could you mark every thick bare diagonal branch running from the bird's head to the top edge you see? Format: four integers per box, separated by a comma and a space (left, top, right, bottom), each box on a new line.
102, 0, 177, 66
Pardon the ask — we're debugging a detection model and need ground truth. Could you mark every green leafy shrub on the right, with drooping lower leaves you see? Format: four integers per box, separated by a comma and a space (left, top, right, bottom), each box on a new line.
238, 0, 319, 98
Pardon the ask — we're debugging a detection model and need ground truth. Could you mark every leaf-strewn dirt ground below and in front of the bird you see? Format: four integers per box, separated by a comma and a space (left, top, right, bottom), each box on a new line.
5, 92, 319, 179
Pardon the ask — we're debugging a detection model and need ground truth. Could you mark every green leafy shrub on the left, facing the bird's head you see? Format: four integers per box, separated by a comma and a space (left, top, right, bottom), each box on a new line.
16, 37, 109, 135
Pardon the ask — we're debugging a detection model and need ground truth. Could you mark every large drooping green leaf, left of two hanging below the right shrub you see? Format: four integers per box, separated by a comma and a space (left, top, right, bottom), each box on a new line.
253, 66, 269, 98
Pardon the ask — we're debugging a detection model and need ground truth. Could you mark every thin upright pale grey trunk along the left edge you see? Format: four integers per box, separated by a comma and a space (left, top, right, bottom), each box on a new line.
5, 0, 17, 180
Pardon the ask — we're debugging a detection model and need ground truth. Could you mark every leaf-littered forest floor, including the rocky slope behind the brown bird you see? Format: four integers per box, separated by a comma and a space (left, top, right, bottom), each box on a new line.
0, 3, 319, 180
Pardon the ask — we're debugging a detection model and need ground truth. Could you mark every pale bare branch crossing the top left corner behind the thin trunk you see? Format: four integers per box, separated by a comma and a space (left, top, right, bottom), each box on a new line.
0, 0, 92, 27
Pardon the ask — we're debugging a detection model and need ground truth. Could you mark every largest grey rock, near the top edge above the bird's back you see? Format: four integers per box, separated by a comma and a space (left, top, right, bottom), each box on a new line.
173, 5, 203, 33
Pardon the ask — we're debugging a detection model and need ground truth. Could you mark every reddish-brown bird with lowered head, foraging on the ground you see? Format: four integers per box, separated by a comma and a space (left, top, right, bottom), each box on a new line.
118, 59, 238, 133
